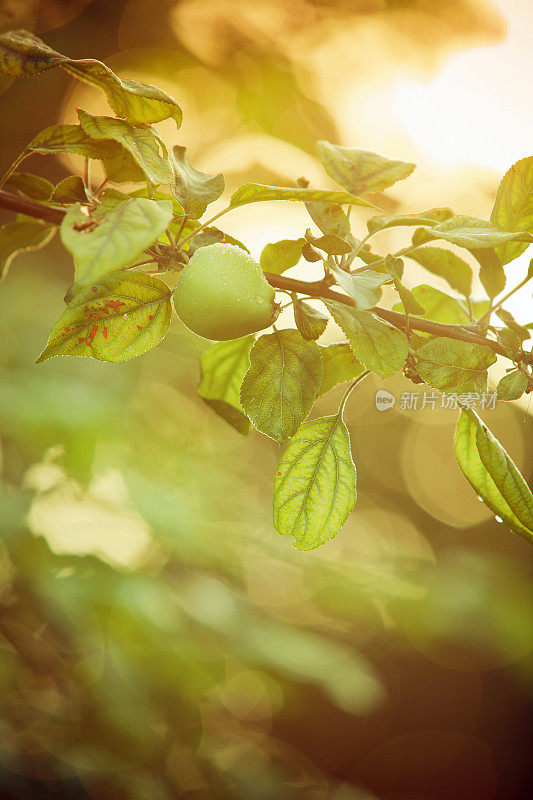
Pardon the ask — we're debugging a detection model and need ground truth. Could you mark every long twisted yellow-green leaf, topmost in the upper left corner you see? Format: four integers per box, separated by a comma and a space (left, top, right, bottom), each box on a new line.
0, 30, 182, 127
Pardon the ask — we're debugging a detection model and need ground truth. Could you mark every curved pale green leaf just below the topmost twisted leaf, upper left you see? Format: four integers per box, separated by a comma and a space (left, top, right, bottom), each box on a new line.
77, 108, 171, 188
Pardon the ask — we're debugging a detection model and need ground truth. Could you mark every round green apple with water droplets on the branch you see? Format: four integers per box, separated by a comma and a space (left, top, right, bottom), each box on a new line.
174, 243, 279, 340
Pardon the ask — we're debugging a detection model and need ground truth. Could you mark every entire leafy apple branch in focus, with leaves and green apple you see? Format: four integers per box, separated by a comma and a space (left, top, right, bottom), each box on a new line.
0, 26, 533, 550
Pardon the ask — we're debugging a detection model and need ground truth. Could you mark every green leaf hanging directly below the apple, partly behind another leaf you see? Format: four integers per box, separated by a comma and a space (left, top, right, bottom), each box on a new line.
197, 336, 255, 435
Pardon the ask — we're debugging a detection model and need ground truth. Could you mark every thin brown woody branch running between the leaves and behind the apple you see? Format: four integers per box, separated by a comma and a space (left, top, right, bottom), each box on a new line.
0, 189, 533, 365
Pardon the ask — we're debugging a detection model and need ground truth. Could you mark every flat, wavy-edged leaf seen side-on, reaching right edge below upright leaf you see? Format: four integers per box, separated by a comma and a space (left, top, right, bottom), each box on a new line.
413, 215, 533, 249
